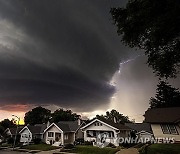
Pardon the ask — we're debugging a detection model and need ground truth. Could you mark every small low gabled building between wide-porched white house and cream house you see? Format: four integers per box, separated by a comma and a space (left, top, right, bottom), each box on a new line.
125, 123, 153, 140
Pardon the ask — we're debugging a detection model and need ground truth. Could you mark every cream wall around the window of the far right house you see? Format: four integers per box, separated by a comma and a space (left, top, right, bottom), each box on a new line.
151, 124, 180, 142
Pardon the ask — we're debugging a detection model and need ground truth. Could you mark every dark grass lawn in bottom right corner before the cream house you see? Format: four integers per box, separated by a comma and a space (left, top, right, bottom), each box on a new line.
141, 144, 180, 154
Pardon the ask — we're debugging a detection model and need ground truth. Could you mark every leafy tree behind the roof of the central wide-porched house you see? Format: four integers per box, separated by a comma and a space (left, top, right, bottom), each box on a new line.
96, 109, 131, 124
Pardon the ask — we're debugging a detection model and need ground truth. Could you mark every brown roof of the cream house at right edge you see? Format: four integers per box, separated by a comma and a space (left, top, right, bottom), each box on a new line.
145, 107, 180, 123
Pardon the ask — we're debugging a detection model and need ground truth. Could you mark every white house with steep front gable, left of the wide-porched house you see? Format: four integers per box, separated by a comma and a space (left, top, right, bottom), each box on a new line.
44, 120, 83, 146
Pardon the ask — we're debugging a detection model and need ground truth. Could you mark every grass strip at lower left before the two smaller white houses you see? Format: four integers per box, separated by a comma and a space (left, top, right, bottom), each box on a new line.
22, 144, 58, 151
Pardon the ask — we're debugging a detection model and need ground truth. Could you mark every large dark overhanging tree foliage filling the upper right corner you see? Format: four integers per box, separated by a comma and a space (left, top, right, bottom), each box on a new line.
110, 0, 180, 78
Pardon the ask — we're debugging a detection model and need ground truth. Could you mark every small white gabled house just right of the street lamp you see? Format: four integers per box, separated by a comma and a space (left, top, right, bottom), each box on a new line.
19, 124, 47, 144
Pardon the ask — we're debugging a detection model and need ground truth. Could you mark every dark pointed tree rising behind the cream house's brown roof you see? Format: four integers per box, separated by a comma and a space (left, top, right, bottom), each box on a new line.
150, 81, 180, 108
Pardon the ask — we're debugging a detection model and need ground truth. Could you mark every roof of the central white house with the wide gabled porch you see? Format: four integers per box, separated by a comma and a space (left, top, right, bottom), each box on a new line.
83, 118, 131, 130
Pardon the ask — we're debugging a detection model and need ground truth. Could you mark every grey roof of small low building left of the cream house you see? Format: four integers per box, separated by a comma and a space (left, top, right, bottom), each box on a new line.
125, 123, 152, 133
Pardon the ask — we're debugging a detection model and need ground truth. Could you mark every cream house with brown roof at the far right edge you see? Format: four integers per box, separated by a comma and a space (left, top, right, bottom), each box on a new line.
145, 107, 180, 142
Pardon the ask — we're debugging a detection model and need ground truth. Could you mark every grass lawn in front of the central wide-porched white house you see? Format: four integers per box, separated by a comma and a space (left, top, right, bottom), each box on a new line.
67, 146, 119, 154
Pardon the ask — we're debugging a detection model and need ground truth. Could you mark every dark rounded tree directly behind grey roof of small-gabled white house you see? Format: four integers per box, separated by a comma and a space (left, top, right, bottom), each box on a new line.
52, 108, 80, 122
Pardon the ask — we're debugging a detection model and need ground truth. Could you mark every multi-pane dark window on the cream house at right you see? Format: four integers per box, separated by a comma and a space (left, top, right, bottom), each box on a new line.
161, 124, 178, 134
